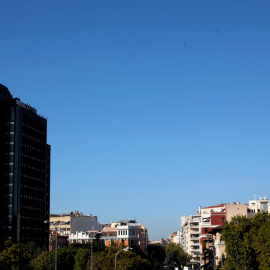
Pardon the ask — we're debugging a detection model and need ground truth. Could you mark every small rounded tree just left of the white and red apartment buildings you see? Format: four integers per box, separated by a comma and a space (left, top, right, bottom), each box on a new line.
166, 243, 190, 269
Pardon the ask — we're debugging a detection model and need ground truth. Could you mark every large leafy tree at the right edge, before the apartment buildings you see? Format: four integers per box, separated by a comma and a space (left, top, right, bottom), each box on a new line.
223, 211, 270, 270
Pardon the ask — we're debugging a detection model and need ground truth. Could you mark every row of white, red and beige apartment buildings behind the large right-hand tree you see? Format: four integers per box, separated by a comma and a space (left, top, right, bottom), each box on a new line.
180, 196, 270, 266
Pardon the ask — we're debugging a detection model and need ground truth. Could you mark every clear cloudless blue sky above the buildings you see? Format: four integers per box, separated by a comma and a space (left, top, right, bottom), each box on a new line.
0, 0, 270, 240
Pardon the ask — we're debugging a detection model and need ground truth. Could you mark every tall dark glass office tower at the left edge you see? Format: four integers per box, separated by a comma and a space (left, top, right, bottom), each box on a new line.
0, 84, 50, 249
